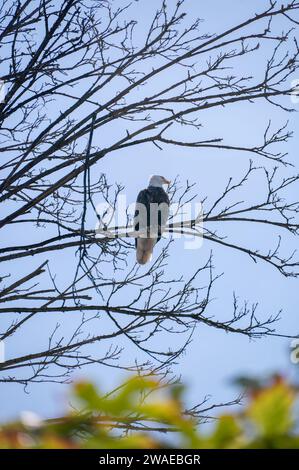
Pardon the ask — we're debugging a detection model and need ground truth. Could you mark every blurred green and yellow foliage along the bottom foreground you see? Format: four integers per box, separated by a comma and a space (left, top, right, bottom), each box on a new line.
0, 375, 299, 449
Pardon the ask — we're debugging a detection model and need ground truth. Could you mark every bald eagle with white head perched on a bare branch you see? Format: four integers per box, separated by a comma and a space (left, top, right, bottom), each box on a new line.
134, 175, 170, 264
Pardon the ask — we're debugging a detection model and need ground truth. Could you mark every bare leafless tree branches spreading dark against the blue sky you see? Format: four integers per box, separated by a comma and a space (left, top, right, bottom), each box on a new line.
0, 0, 299, 392
